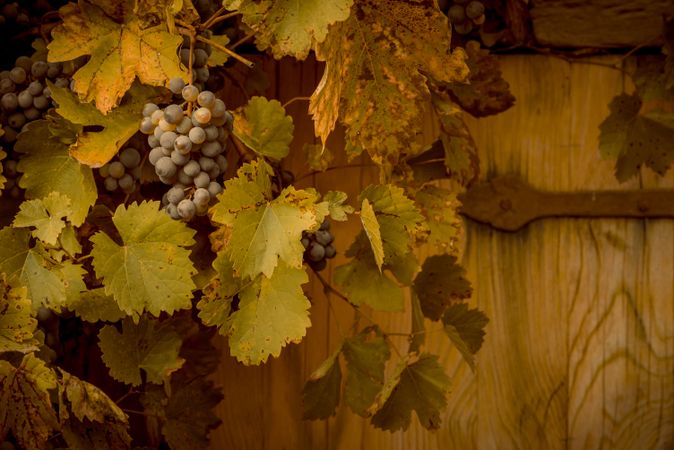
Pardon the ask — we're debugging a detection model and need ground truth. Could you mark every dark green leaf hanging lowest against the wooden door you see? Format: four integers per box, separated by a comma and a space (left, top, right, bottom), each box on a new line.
372, 353, 450, 431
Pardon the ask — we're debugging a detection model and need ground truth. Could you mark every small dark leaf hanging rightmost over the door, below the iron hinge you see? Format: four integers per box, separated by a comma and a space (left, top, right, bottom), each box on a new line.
442, 303, 489, 370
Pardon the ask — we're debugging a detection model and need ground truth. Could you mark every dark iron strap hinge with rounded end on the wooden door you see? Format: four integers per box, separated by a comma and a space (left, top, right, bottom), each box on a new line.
459, 176, 674, 231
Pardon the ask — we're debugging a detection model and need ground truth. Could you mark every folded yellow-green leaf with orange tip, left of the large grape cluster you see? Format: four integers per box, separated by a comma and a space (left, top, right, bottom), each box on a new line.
49, 83, 158, 167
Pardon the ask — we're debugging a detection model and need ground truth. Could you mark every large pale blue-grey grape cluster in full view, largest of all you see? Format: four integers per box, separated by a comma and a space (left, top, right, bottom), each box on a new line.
139, 78, 234, 221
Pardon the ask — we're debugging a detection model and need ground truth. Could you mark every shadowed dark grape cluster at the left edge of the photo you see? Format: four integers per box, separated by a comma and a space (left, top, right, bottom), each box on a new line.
0, 56, 76, 144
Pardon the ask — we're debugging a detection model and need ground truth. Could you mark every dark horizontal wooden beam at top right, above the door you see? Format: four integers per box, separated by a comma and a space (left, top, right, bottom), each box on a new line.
530, 0, 674, 48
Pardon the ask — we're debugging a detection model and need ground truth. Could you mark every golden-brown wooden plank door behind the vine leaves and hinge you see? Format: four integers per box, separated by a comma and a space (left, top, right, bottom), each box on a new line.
206, 56, 674, 450
